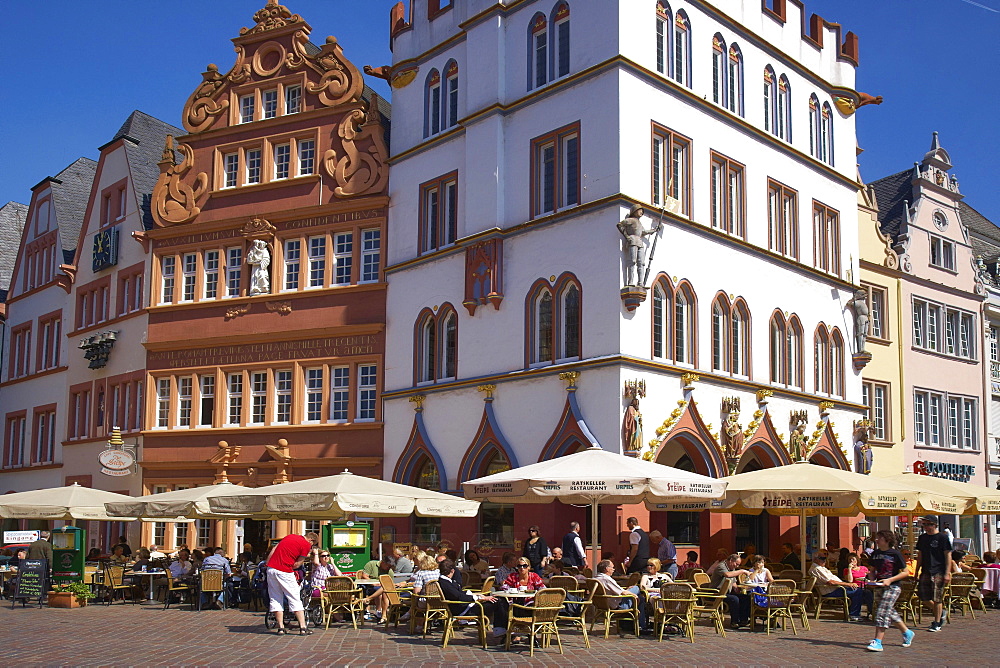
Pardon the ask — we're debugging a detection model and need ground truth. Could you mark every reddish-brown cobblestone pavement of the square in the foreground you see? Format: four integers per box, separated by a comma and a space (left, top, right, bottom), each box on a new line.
0, 601, 988, 668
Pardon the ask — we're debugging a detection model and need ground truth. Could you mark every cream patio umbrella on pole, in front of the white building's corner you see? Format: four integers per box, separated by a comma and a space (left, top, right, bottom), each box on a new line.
462, 447, 726, 566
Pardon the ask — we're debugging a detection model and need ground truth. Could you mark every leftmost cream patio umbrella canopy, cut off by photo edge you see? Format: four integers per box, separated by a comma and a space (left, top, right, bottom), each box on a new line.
0, 483, 135, 522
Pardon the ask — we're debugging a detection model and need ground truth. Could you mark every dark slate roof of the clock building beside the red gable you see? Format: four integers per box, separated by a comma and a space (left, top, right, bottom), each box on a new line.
108, 110, 186, 230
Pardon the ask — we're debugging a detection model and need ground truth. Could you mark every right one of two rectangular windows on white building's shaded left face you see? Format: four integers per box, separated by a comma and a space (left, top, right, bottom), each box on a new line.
531, 123, 580, 217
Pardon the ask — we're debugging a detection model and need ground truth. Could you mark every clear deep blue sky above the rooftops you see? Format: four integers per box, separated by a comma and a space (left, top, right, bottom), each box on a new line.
0, 0, 1000, 222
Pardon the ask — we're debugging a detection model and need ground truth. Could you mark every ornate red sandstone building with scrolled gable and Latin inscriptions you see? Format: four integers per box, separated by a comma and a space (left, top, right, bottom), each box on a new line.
142, 0, 388, 547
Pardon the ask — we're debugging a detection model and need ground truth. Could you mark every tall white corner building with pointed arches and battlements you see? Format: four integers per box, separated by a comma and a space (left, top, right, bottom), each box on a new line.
384, 0, 863, 556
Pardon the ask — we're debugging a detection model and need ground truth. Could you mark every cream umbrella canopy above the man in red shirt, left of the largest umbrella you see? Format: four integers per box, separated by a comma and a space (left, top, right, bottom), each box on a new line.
208, 470, 479, 519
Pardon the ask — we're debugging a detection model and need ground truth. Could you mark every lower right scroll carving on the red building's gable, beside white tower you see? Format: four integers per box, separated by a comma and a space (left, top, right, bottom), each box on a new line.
323, 108, 389, 197
